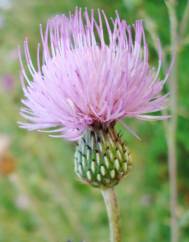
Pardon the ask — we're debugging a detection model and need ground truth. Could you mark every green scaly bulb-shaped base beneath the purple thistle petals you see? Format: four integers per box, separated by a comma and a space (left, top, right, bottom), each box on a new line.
75, 126, 131, 188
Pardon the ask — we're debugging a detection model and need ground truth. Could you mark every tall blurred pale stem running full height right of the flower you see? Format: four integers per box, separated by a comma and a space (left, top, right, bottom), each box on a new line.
167, 0, 179, 242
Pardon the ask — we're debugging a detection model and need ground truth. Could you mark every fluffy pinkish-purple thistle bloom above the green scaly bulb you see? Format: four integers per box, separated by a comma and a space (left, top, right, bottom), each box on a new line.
20, 8, 168, 140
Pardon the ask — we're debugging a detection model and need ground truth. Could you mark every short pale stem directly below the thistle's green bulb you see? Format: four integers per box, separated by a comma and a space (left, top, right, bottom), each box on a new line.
102, 188, 121, 242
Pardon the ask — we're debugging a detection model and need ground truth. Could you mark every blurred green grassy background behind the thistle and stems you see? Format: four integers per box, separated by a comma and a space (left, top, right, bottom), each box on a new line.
0, 0, 189, 242
